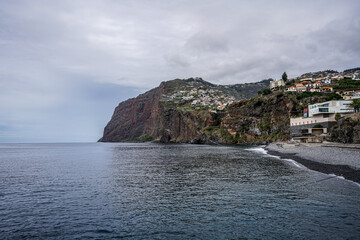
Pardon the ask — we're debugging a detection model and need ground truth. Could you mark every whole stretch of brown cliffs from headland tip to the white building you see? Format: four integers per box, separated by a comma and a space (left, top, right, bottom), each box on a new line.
99, 79, 294, 143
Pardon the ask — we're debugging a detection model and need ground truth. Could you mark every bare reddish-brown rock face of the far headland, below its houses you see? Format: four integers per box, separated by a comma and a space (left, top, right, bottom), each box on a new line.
99, 80, 225, 143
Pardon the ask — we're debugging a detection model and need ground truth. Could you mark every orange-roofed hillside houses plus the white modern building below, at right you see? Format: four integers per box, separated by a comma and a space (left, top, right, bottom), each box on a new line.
270, 68, 360, 142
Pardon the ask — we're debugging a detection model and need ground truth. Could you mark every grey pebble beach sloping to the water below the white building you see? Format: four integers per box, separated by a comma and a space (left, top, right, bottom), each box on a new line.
265, 142, 360, 183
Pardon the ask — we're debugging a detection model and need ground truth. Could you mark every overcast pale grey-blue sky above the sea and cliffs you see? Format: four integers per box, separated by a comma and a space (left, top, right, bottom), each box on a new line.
0, 0, 360, 142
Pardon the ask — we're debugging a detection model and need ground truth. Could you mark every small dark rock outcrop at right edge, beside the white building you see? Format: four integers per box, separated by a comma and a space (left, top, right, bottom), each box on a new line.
330, 113, 360, 143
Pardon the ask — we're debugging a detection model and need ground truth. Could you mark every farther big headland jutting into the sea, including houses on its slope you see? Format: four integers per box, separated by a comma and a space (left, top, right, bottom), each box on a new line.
99, 78, 268, 143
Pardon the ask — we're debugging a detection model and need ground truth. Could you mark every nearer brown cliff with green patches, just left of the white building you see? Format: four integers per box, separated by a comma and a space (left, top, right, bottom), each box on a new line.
221, 93, 296, 143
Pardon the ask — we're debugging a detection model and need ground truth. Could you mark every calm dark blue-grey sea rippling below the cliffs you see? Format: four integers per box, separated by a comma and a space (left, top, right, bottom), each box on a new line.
0, 143, 360, 239
